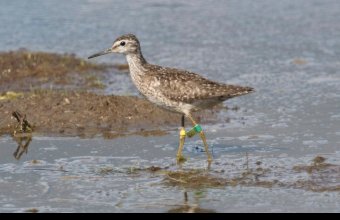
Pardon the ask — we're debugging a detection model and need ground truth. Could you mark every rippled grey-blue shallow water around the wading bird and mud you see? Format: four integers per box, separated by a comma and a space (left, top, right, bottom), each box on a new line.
0, 0, 340, 212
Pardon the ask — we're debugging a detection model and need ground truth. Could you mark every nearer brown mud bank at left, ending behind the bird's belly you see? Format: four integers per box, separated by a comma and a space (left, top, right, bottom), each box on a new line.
0, 91, 186, 137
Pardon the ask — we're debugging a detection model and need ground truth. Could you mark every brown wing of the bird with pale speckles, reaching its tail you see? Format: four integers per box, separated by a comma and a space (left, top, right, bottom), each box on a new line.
147, 66, 253, 104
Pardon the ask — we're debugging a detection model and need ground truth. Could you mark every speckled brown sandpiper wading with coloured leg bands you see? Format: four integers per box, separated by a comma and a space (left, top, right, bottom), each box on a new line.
88, 34, 254, 164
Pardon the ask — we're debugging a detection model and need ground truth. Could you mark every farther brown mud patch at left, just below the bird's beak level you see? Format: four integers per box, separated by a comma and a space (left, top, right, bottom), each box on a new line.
0, 49, 113, 92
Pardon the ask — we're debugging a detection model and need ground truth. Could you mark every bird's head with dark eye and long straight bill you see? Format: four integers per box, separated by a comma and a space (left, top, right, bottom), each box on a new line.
88, 34, 140, 59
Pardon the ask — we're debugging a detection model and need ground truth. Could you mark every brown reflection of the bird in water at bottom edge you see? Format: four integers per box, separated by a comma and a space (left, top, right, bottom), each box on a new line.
168, 192, 216, 213
